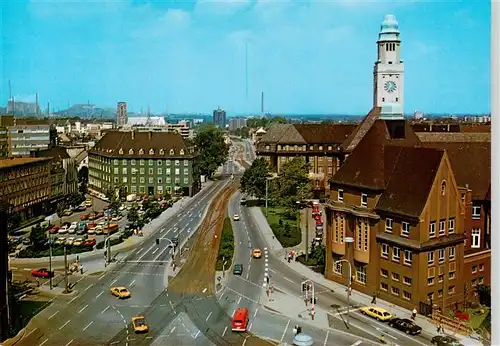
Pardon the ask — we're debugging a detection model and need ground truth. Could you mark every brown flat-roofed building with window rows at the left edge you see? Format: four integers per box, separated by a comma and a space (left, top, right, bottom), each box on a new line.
0, 158, 51, 220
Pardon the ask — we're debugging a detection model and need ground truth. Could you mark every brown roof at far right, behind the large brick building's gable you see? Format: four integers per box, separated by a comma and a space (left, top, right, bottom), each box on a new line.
424, 142, 491, 200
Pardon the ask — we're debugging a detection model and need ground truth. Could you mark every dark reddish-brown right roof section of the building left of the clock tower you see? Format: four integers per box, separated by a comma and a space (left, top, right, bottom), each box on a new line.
294, 124, 357, 144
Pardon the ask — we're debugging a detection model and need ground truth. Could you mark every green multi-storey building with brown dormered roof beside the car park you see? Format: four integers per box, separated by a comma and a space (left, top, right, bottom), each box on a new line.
89, 131, 201, 196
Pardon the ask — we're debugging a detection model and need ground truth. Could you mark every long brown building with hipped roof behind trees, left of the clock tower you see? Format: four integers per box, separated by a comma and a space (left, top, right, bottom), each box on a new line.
256, 124, 356, 191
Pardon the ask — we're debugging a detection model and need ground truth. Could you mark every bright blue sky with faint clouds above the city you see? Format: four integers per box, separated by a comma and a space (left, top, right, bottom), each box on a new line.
0, 0, 491, 115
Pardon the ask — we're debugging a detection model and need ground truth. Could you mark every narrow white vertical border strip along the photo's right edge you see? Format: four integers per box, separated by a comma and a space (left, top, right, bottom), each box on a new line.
490, 0, 500, 345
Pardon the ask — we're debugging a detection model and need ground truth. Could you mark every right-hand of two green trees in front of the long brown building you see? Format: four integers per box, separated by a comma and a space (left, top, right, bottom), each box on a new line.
271, 157, 311, 209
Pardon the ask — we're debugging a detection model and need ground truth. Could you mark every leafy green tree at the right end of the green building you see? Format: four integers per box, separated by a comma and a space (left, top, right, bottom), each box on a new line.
194, 125, 229, 179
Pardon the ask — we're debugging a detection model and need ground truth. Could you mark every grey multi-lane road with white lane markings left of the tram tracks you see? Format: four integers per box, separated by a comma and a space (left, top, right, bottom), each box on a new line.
17, 181, 228, 346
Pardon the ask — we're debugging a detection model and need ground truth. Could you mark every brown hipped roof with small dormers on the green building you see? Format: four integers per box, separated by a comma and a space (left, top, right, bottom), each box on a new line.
90, 131, 193, 158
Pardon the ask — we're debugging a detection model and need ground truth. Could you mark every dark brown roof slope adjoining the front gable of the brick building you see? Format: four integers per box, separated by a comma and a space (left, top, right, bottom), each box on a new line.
375, 146, 444, 217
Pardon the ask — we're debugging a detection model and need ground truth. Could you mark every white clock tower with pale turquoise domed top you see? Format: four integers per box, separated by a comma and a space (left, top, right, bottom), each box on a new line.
373, 14, 404, 113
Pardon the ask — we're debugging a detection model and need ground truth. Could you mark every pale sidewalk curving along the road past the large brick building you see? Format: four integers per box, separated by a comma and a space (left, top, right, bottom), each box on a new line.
250, 207, 481, 346
